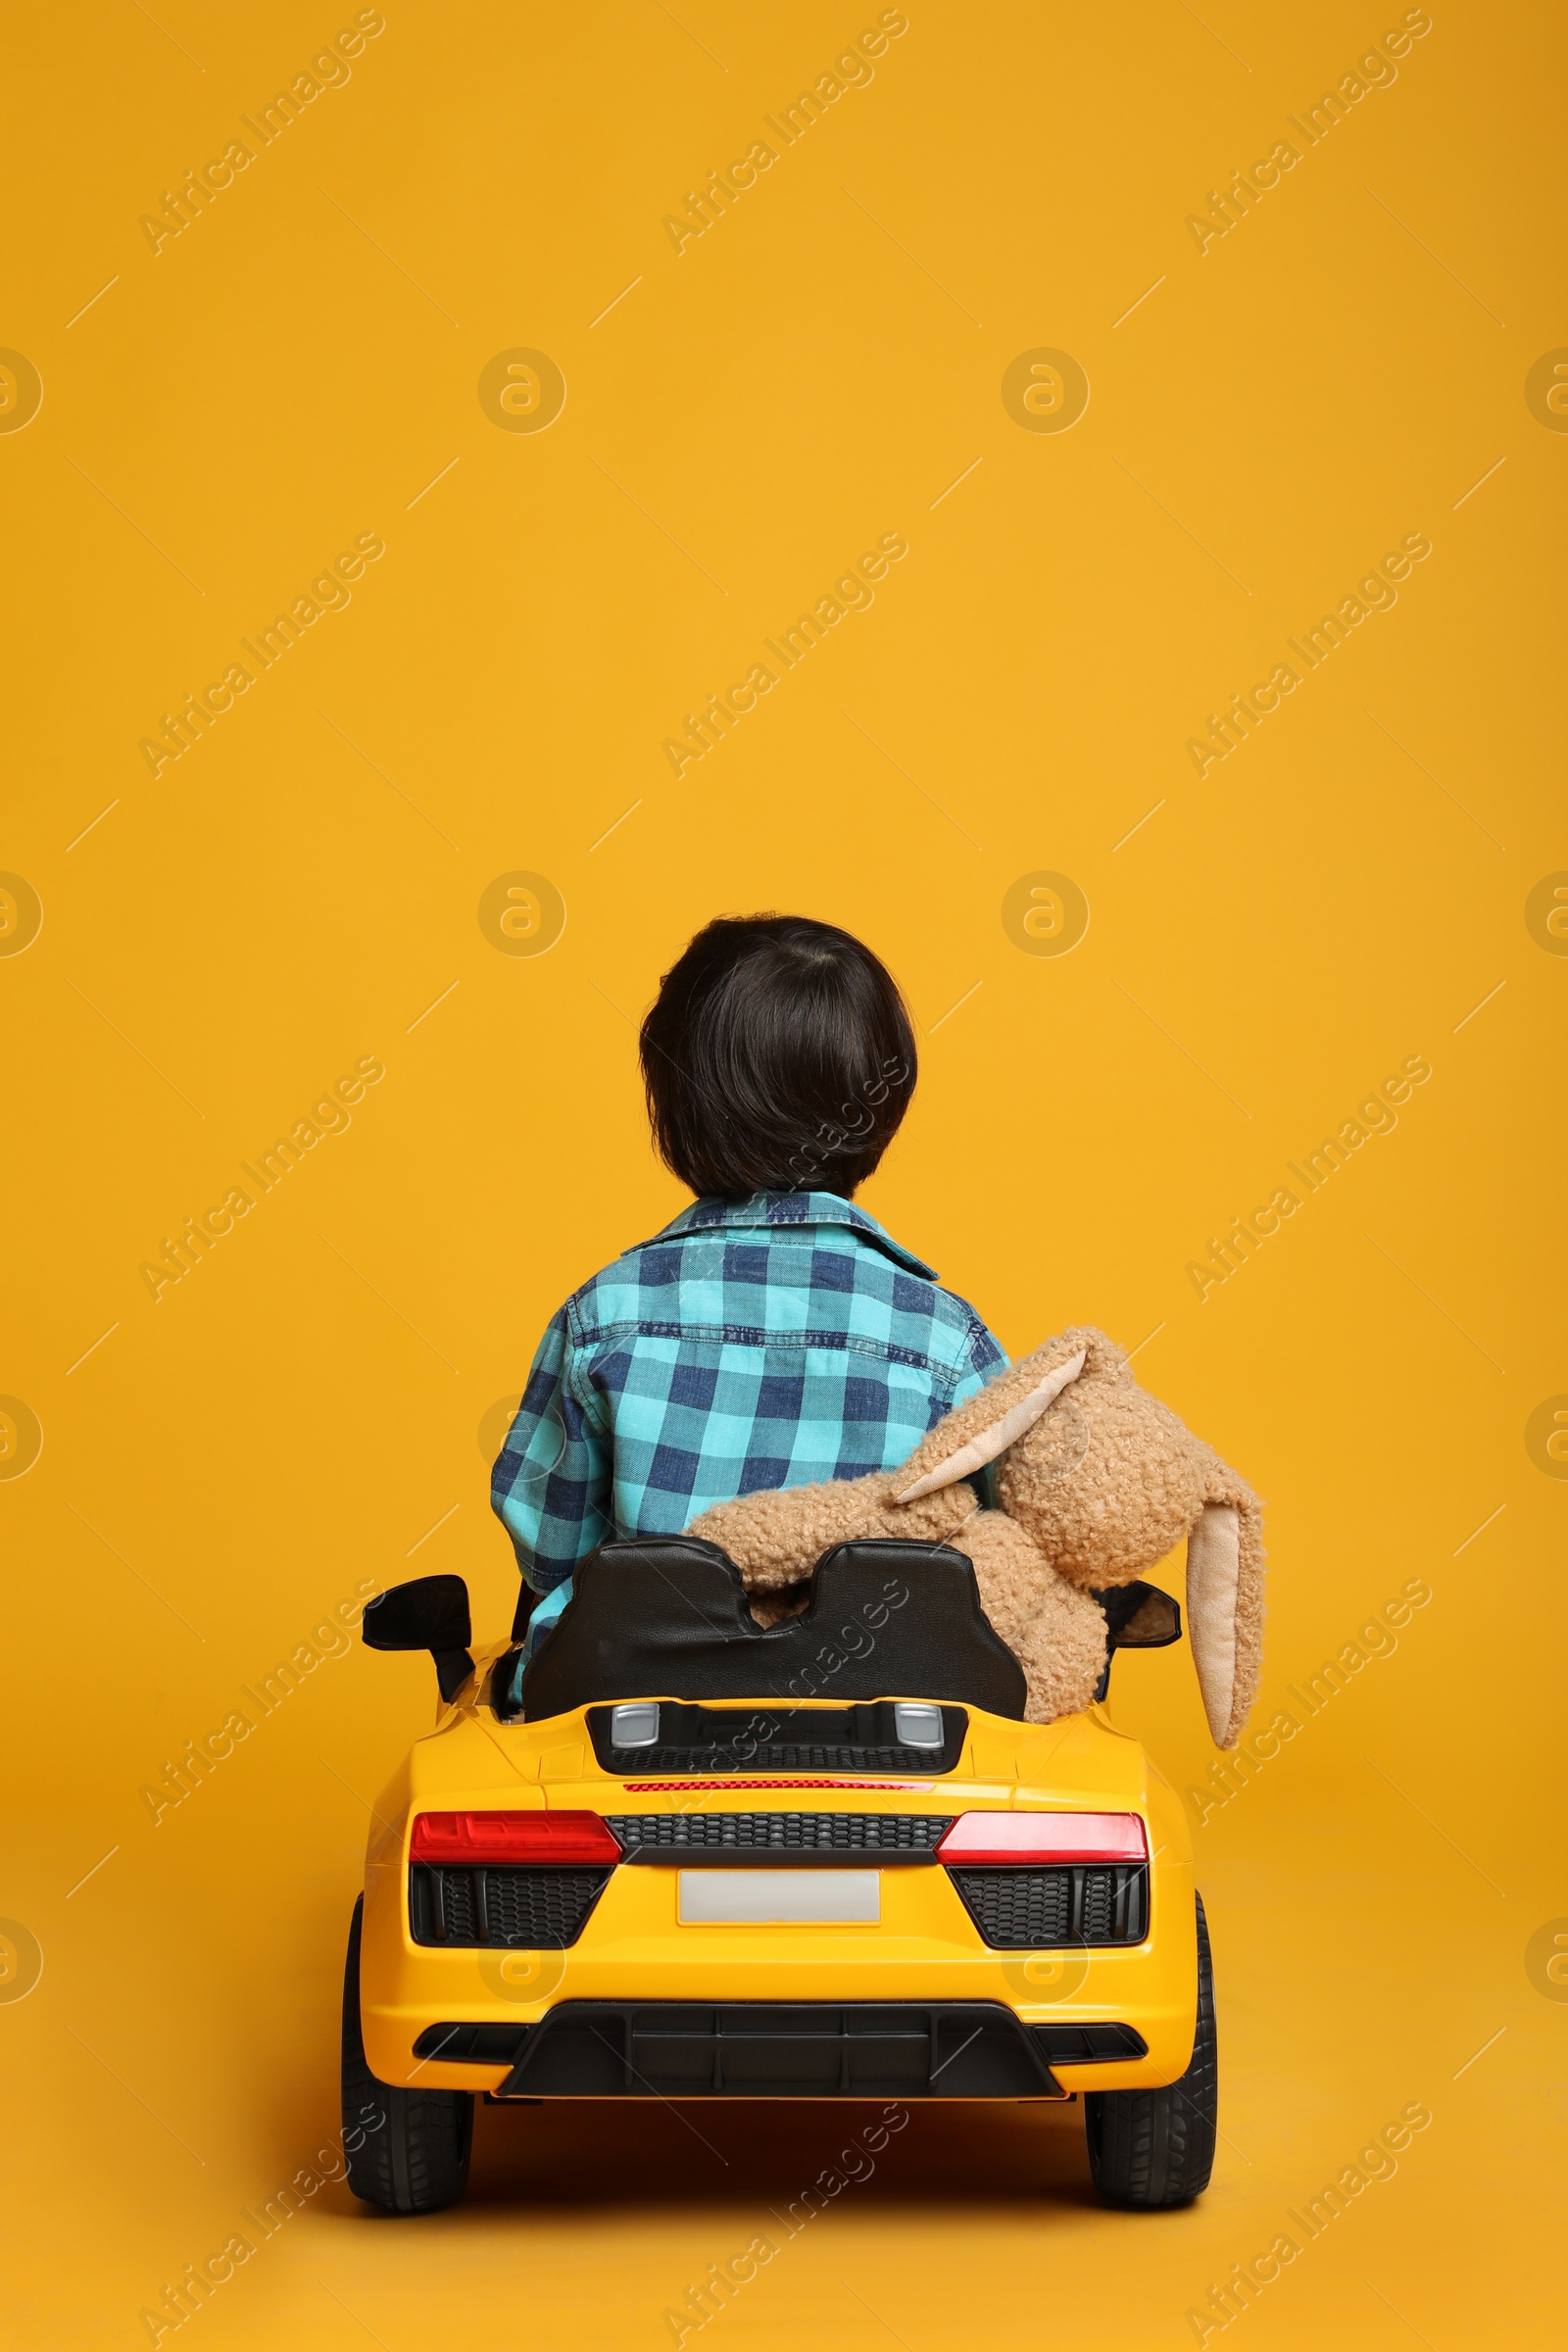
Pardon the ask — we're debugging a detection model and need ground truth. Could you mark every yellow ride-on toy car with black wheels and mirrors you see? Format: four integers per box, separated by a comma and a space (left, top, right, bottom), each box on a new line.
343, 1539, 1215, 2213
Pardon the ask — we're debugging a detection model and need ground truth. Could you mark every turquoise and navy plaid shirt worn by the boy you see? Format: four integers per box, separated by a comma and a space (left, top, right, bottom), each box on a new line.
491, 1193, 1006, 1630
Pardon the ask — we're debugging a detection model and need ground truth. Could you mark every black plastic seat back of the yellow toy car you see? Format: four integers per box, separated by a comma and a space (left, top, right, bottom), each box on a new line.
519, 1536, 1027, 1722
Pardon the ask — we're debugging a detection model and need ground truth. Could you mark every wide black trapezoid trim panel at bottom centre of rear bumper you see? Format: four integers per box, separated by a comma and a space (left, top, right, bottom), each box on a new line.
496, 2001, 1065, 2098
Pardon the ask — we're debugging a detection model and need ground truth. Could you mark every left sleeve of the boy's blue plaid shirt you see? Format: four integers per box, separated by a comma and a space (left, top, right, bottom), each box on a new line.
489, 1307, 615, 1592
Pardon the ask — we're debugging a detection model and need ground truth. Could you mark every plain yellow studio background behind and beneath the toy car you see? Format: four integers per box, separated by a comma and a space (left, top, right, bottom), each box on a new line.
0, 0, 1568, 2352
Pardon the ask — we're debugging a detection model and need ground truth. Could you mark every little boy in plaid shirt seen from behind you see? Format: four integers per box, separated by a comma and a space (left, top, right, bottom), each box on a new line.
491, 915, 1006, 1648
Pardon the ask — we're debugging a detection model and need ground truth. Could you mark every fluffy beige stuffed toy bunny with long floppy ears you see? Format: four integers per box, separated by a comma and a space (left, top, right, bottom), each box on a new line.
686, 1329, 1262, 1747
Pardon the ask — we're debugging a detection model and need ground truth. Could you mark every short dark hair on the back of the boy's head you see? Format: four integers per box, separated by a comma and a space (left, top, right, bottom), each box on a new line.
642, 915, 914, 1200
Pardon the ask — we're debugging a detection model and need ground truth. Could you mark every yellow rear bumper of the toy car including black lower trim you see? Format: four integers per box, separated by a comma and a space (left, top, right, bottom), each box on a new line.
362, 1860, 1197, 2098
